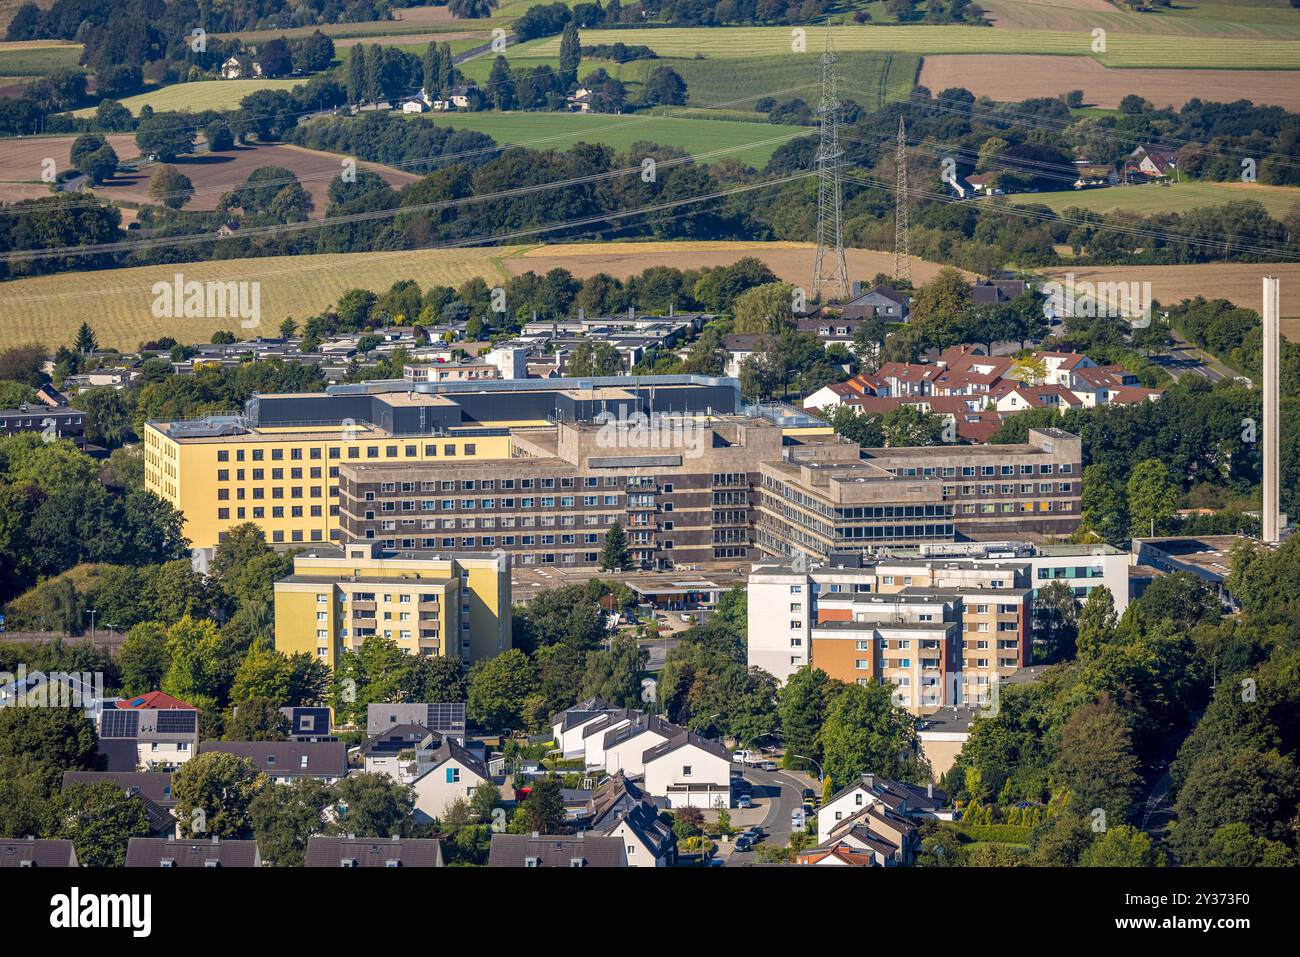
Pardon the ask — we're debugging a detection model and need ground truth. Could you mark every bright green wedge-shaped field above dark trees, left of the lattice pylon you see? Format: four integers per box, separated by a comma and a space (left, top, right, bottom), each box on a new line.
410, 113, 795, 168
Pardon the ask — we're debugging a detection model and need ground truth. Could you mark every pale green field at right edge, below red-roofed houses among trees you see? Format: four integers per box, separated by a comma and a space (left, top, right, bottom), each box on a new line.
1008, 182, 1300, 217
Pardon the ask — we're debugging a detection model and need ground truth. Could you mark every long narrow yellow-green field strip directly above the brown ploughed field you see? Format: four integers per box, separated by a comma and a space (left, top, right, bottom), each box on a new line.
524, 26, 1300, 70
